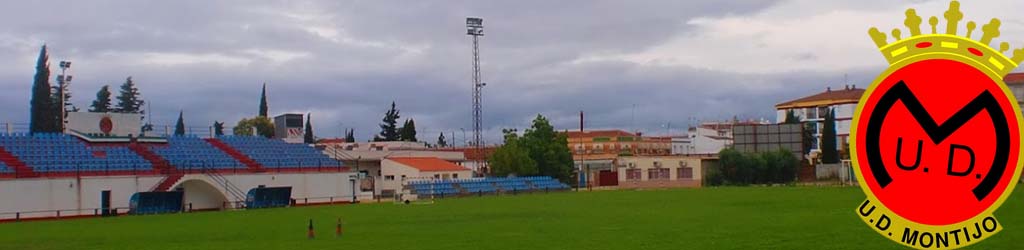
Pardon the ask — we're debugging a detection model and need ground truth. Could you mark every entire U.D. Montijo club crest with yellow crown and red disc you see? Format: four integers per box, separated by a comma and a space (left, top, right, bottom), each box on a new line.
850, 1, 1024, 249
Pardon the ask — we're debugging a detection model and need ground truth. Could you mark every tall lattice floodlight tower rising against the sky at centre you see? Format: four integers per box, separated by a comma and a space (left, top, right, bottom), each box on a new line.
466, 17, 487, 173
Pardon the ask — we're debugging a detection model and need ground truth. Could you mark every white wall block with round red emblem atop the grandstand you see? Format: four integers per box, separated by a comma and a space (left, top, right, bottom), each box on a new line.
67, 112, 142, 136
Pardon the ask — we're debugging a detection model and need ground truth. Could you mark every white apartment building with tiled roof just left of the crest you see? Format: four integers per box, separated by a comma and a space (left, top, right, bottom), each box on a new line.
775, 85, 864, 154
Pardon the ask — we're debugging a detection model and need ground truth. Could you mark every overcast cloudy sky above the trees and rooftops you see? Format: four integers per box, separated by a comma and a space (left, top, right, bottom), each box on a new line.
0, 0, 1024, 141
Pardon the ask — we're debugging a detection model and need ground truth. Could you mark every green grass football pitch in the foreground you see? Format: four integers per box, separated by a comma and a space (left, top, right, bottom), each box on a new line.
0, 188, 1024, 250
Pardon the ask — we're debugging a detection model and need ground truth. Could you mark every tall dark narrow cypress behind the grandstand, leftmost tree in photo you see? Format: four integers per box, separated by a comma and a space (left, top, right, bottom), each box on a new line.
29, 44, 57, 133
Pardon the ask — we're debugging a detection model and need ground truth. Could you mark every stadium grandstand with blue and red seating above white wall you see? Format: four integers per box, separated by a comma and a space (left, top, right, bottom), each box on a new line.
0, 113, 364, 220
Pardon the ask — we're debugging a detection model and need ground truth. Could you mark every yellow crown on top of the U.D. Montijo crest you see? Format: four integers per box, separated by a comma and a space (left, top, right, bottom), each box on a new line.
867, 1, 1024, 76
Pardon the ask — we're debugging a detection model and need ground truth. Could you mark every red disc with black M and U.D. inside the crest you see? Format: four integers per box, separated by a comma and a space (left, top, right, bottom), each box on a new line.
854, 59, 1021, 225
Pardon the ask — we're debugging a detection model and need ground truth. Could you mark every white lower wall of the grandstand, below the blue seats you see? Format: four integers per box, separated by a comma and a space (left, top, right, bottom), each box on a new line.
0, 172, 373, 219
